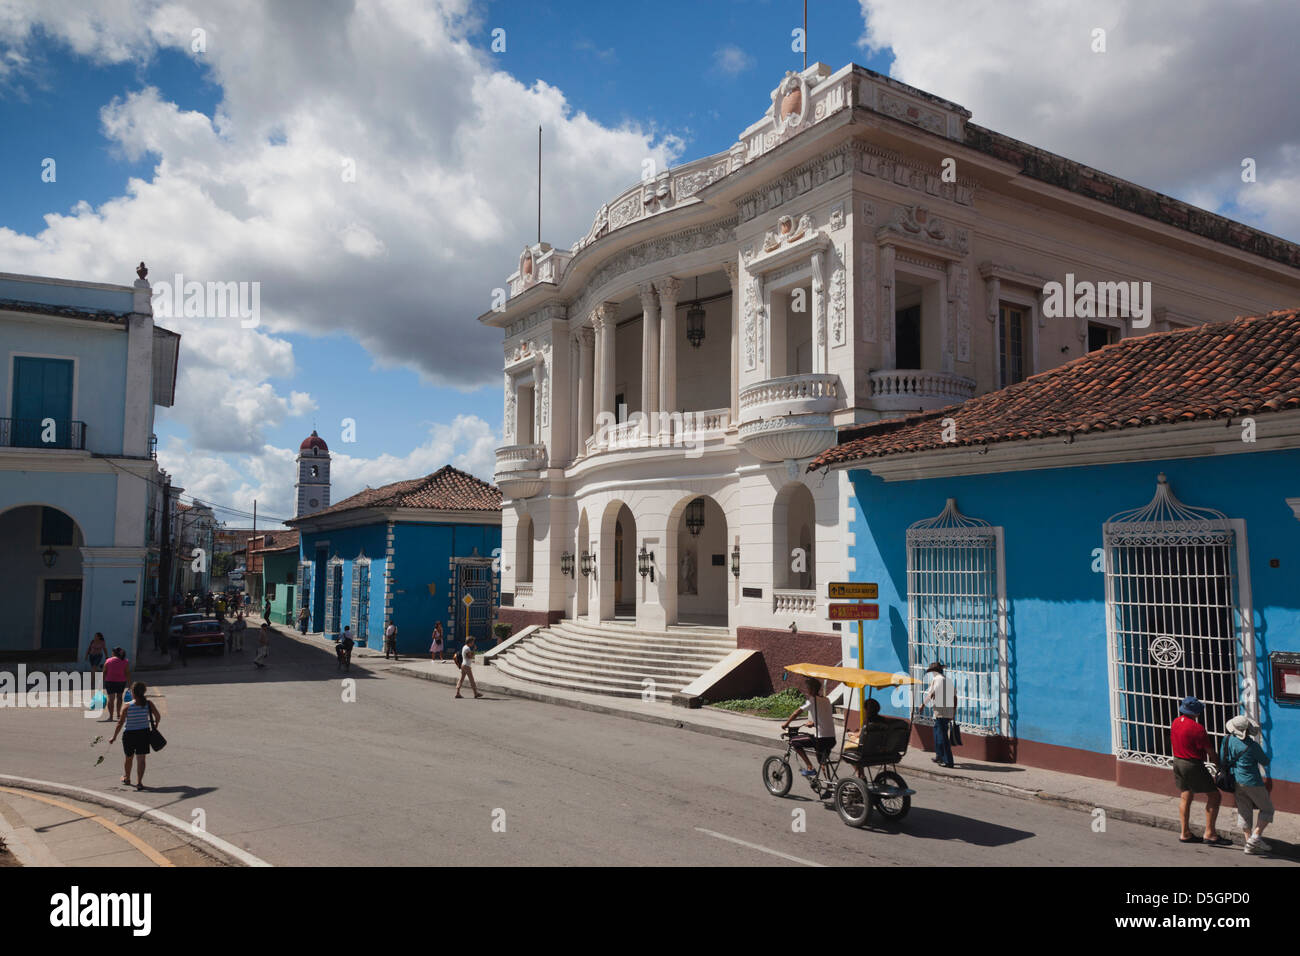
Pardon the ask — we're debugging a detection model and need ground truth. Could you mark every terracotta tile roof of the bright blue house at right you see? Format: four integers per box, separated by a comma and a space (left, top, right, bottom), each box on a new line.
809, 310, 1300, 471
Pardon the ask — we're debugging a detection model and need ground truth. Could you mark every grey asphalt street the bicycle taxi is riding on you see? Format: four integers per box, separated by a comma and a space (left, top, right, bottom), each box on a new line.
0, 637, 1295, 866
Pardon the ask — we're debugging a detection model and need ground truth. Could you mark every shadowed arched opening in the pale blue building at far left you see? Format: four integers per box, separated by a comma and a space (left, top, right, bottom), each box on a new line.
0, 505, 83, 657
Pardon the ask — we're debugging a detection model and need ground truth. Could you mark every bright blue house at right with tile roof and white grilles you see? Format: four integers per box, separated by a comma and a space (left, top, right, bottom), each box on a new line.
813, 311, 1300, 810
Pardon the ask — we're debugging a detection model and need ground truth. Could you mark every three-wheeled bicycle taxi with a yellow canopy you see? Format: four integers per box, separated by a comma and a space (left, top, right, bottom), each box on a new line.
763, 663, 920, 827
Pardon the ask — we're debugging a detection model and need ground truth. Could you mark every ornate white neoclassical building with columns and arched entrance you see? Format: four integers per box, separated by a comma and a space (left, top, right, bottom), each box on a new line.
480, 64, 1300, 697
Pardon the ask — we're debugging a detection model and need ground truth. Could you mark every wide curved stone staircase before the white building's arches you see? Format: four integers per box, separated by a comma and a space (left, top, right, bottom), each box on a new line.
491, 620, 736, 702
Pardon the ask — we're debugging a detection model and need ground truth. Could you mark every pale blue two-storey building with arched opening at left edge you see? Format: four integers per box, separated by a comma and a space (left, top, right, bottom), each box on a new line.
0, 264, 181, 661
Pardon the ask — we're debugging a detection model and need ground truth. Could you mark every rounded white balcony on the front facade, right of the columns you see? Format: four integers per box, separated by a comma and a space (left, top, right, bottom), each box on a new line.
740, 372, 844, 462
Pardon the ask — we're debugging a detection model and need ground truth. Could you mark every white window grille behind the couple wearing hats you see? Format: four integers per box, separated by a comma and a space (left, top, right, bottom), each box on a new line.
1102, 475, 1257, 766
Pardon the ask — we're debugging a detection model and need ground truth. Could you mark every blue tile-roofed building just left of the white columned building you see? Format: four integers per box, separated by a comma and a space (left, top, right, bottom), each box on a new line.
289, 465, 501, 654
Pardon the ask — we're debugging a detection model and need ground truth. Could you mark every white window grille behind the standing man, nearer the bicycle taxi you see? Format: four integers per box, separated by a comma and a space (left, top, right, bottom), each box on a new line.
907, 498, 1009, 735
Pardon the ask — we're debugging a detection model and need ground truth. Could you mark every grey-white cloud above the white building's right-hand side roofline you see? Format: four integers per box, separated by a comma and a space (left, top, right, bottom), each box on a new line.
861, 0, 1300, 238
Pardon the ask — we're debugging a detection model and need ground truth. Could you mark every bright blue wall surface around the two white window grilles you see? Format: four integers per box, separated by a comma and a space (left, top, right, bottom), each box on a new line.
849, 451, 1300, 780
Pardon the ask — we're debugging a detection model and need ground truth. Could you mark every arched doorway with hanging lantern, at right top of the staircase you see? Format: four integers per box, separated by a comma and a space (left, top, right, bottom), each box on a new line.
664, 496, 732, 627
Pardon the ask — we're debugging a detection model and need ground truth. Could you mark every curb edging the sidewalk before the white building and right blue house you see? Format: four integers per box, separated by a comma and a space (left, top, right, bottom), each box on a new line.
390, 666, 1290, 858
